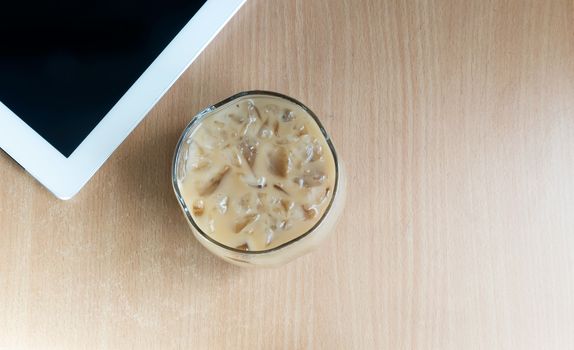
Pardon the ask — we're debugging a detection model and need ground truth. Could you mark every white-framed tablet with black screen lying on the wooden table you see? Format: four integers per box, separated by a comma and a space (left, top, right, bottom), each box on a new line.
0, 0, 245, 199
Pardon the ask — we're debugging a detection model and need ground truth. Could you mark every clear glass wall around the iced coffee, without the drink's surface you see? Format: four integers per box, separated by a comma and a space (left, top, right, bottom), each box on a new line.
172, 91, 346, 266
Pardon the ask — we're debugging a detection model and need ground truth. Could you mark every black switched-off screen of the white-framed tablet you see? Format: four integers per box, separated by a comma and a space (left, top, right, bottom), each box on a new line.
0, 0, 205, 157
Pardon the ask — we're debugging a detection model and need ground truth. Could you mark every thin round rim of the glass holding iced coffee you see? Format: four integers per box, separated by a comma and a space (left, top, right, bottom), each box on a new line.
171, 90, 339, 255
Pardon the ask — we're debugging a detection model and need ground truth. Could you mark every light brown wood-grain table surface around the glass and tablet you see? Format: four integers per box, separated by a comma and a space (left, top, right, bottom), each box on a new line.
0, 0, 574, 349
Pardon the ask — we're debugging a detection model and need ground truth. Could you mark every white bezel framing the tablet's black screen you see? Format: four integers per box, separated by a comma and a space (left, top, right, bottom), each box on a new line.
0, 0, 246, 199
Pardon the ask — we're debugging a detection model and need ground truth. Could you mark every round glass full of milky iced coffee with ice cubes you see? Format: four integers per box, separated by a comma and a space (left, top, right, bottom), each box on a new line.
172, 91, 345, 266
